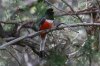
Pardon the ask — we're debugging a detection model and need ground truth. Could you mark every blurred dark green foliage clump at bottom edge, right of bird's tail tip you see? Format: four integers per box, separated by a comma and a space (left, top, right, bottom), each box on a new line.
48, 51, 66, 66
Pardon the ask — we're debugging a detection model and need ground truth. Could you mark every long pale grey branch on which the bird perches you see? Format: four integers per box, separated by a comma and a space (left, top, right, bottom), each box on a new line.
0, 23, 100, 49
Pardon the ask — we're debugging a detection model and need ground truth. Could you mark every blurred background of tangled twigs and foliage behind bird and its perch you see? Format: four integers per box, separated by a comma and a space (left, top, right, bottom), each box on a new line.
0, 0, 100, 66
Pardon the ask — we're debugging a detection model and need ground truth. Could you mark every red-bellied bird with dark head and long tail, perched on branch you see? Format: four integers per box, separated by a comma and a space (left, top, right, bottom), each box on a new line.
39, 8, 54, 56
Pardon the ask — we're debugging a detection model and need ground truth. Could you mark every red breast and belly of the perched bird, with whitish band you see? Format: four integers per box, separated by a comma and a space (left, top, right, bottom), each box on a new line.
40, 20, 53, 38
